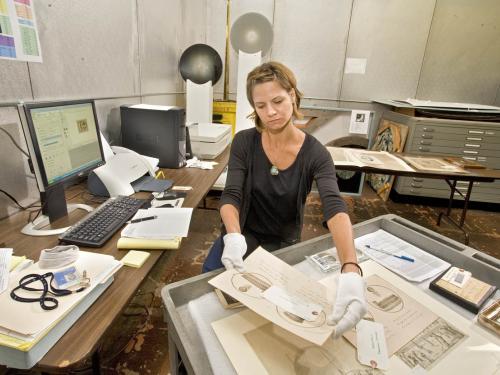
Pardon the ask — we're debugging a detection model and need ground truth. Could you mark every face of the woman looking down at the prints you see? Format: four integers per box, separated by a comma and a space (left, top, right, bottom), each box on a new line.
253, 81, 294, 132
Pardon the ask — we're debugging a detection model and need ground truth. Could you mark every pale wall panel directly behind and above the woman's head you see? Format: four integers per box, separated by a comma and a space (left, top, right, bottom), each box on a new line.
272, 0, 352, 99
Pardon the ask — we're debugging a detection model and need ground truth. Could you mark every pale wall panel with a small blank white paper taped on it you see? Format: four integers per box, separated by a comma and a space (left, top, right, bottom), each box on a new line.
340, 0, 435, 100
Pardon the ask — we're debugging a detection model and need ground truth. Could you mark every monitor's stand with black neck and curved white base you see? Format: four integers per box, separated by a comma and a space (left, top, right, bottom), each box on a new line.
21, 185, 93, 236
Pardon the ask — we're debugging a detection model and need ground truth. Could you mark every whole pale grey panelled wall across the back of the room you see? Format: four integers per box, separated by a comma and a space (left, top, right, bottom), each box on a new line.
0, 0, 500, 217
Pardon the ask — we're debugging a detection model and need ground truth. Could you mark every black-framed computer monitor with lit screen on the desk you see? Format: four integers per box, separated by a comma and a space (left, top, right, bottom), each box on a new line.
19, 100, 105, 222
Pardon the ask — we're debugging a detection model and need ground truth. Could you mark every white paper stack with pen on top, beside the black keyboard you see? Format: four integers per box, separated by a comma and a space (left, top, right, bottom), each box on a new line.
117, 208, 193, 250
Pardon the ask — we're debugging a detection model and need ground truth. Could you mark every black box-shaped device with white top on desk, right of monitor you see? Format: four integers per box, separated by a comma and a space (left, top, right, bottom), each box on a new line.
120, 104, 189, 168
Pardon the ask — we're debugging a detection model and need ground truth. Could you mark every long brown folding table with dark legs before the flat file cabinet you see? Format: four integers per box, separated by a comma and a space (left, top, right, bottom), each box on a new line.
335, 153, 500, 245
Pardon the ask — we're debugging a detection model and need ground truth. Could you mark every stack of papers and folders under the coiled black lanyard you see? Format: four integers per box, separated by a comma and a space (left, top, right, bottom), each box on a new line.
0, 251, 122, 368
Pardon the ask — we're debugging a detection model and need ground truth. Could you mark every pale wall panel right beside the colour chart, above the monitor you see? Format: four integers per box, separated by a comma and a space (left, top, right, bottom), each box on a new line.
29, 0, 139, 100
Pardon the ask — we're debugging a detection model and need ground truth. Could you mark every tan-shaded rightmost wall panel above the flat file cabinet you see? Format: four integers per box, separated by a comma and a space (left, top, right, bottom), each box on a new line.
417, 0, 500, 105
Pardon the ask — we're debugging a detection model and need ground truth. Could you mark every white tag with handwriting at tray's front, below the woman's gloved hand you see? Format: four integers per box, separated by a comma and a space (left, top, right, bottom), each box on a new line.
356, 319, 389, 370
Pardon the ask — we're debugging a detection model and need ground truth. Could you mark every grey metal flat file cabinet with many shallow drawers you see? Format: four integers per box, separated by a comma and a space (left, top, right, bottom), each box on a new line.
382, 112, 500, 203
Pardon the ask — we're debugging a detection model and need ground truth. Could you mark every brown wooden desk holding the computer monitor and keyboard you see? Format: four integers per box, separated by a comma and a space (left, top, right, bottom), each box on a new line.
0, 148, 229, 373
